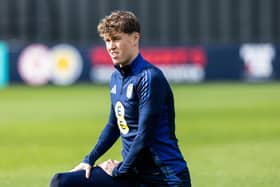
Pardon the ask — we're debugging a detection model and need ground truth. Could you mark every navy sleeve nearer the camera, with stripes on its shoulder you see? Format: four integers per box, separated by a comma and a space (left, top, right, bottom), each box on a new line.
113, 70, 164, 177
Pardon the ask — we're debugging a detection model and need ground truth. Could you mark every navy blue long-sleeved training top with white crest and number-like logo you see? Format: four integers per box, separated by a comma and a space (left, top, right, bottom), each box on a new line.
84, 54, 187, 183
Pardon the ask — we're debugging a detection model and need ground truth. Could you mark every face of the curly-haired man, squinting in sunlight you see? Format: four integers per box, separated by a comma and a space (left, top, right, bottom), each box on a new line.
103, 32, 139, 66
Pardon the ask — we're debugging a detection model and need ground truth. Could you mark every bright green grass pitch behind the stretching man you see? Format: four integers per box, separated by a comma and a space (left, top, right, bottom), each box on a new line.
0, 83, 280, 187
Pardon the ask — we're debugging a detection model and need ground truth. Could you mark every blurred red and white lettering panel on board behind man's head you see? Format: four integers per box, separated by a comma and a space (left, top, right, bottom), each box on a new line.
89, 46, 207, 83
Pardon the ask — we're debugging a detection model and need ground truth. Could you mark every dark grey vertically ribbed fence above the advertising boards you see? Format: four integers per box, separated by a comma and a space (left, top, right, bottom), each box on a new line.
0, 0, 280, 45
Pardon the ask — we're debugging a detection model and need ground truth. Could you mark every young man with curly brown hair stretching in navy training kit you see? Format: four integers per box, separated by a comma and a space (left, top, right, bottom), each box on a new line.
51, 11, 191, 187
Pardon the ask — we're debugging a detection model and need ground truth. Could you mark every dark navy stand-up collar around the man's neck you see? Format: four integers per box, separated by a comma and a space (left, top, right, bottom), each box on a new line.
115, 53, 144, 77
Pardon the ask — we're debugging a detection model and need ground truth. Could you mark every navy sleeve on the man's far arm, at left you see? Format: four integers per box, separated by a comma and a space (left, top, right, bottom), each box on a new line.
83, 106, 120, 165
